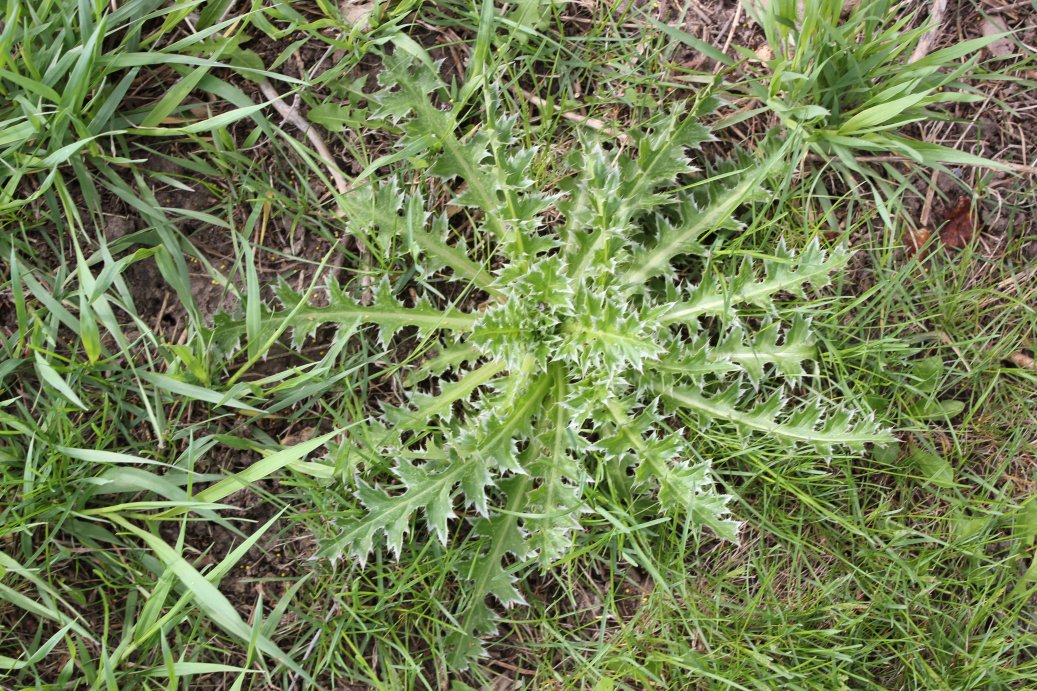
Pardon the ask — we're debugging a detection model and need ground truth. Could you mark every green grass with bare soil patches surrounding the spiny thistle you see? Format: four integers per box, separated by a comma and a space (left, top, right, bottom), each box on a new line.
0, 0, 1037, 689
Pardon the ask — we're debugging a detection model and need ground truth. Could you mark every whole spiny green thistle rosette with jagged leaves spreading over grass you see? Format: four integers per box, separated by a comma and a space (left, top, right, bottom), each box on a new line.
214, 56, 891, 664
